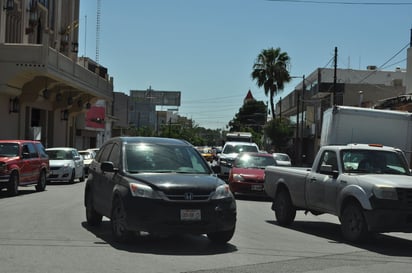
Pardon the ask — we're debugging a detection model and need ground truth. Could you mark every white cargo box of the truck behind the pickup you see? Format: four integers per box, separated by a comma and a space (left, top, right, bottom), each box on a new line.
320, 106, 412, 164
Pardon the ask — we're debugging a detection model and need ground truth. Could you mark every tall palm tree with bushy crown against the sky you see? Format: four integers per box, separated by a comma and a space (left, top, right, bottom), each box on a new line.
251, 47, 291, 119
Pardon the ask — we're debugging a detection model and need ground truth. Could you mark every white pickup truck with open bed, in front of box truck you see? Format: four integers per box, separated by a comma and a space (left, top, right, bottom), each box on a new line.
264, 144, 412, 242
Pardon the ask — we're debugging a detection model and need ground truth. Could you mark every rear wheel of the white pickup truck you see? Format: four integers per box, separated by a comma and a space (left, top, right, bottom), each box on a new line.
274, 190, 296, 226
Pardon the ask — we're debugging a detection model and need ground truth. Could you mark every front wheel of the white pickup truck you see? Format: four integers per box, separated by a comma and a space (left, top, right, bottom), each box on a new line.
340, 203, 368, 242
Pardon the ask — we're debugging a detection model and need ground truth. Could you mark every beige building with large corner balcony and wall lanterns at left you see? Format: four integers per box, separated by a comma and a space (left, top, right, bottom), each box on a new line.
0, 0, 113, 149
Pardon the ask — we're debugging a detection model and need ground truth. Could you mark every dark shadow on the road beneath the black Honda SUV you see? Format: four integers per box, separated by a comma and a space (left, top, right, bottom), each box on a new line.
82, 221, 237, 255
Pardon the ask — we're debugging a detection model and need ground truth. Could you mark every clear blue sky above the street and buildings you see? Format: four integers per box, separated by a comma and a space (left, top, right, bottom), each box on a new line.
79, 0, 412, 129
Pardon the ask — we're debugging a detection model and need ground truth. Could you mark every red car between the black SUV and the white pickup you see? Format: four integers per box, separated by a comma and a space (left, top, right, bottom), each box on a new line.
228, 153, 276, 196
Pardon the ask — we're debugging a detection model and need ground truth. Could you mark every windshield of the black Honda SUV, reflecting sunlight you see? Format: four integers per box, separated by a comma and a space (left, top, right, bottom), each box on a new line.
125, 143, 210, 174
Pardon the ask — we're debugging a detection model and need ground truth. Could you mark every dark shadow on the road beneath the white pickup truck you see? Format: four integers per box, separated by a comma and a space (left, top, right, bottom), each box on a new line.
266, 218, 412, 257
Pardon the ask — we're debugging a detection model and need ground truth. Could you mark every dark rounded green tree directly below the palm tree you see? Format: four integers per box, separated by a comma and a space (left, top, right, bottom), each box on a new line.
264, 118, 294, 152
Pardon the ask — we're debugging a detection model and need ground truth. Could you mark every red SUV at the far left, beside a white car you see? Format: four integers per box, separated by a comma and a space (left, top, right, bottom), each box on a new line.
0, 140, 50, 196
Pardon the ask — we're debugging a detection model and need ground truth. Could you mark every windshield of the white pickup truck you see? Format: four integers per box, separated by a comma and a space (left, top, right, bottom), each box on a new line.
341, 150, 409, 174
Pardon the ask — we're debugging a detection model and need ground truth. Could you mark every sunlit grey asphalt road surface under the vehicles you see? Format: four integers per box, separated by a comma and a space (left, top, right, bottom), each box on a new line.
0, 178, 412, 273
